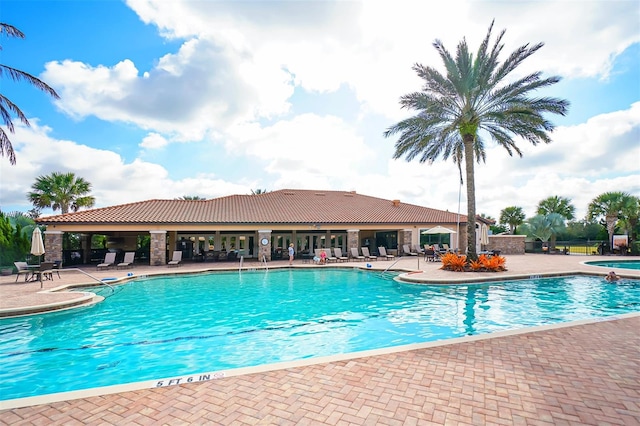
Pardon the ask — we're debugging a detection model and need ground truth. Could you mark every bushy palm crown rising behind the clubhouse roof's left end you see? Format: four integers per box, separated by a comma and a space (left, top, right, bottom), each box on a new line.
27, 172, 96, 214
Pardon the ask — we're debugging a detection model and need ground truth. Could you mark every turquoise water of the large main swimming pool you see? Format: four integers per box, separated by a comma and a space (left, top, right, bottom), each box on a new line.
0, 269, 640, 400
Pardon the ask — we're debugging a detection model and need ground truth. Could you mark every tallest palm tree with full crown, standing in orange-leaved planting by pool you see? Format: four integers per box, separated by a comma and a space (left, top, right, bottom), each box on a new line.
384, 22, 569, 260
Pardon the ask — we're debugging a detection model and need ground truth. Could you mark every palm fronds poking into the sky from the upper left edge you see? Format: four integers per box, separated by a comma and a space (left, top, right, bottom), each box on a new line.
0, 22, 60, 164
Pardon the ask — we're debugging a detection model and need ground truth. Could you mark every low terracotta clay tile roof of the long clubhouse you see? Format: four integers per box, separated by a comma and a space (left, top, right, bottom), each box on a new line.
37, 189, 466, 224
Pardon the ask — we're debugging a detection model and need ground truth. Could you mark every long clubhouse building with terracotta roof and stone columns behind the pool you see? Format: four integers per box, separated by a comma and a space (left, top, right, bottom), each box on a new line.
37, 189, 467, 265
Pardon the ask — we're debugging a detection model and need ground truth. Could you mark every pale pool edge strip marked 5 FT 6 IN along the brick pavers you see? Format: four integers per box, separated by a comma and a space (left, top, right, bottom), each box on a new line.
0, 312, 640, 410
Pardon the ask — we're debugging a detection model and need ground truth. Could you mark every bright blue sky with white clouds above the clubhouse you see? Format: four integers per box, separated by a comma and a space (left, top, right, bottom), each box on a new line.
0, 0, 640, 219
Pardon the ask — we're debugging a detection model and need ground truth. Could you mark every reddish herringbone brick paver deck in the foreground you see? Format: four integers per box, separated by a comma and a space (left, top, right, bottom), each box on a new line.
0, 256, 640, 425
